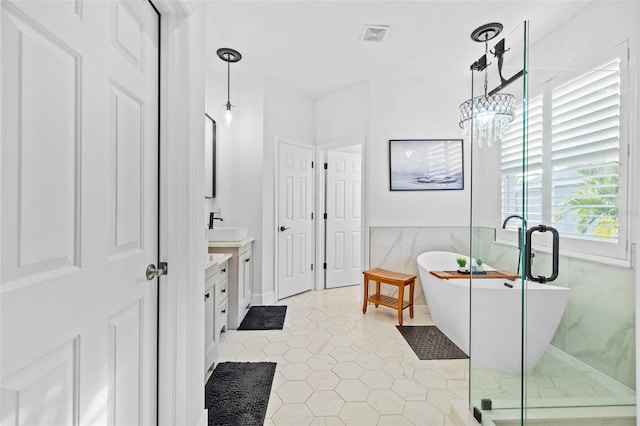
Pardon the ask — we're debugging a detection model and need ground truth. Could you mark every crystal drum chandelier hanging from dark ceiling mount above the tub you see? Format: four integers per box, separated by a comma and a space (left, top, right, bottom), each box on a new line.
459, 23, 516, 147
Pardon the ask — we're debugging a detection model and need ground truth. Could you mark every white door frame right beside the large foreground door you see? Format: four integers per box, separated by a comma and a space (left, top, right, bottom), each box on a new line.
152, 0, 207, 426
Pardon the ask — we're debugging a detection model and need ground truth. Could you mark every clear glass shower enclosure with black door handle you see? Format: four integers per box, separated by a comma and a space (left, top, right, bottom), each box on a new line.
465, 1, 640, 426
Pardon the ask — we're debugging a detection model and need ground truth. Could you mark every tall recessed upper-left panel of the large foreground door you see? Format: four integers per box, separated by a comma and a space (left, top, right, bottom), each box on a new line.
2, 1, 81, 288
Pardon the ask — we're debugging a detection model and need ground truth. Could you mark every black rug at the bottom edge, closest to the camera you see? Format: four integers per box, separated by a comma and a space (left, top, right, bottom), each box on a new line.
204, 362, 276, 426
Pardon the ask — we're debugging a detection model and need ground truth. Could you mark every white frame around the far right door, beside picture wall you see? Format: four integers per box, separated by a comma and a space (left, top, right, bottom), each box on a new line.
315, 136, 369, 290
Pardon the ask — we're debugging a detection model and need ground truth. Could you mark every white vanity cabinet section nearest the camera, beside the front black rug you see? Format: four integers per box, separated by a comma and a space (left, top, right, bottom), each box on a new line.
204, 253, 231, 372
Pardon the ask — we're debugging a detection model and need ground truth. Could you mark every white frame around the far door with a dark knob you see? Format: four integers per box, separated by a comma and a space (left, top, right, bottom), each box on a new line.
273, 136, 320, 301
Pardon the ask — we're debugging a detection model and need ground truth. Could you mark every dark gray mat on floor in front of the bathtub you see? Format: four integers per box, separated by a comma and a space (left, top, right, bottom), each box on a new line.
396, 325, 469, 359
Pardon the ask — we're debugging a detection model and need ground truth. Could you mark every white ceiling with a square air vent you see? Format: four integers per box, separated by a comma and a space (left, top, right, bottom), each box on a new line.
206, 0, 585, 98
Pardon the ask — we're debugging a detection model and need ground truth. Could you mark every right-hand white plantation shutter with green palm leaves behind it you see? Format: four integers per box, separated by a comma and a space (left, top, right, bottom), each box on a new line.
551, 60, 621, 243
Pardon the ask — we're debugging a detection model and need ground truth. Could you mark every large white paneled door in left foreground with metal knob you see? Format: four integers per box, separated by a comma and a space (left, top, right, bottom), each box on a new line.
0, 0, 159, 425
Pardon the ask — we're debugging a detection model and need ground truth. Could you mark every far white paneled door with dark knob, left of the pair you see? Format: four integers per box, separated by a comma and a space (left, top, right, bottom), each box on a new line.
278, 142, 313, 299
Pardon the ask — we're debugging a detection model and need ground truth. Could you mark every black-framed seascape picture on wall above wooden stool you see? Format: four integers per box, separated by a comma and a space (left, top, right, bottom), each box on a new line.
389, 139, 464, 191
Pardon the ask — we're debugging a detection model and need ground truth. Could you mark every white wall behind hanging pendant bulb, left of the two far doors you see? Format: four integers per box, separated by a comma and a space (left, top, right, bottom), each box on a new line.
203, 73, 315, 304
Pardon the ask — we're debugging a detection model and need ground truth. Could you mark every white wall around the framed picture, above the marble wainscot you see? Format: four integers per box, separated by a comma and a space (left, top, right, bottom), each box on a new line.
316, 77, 470, 267
